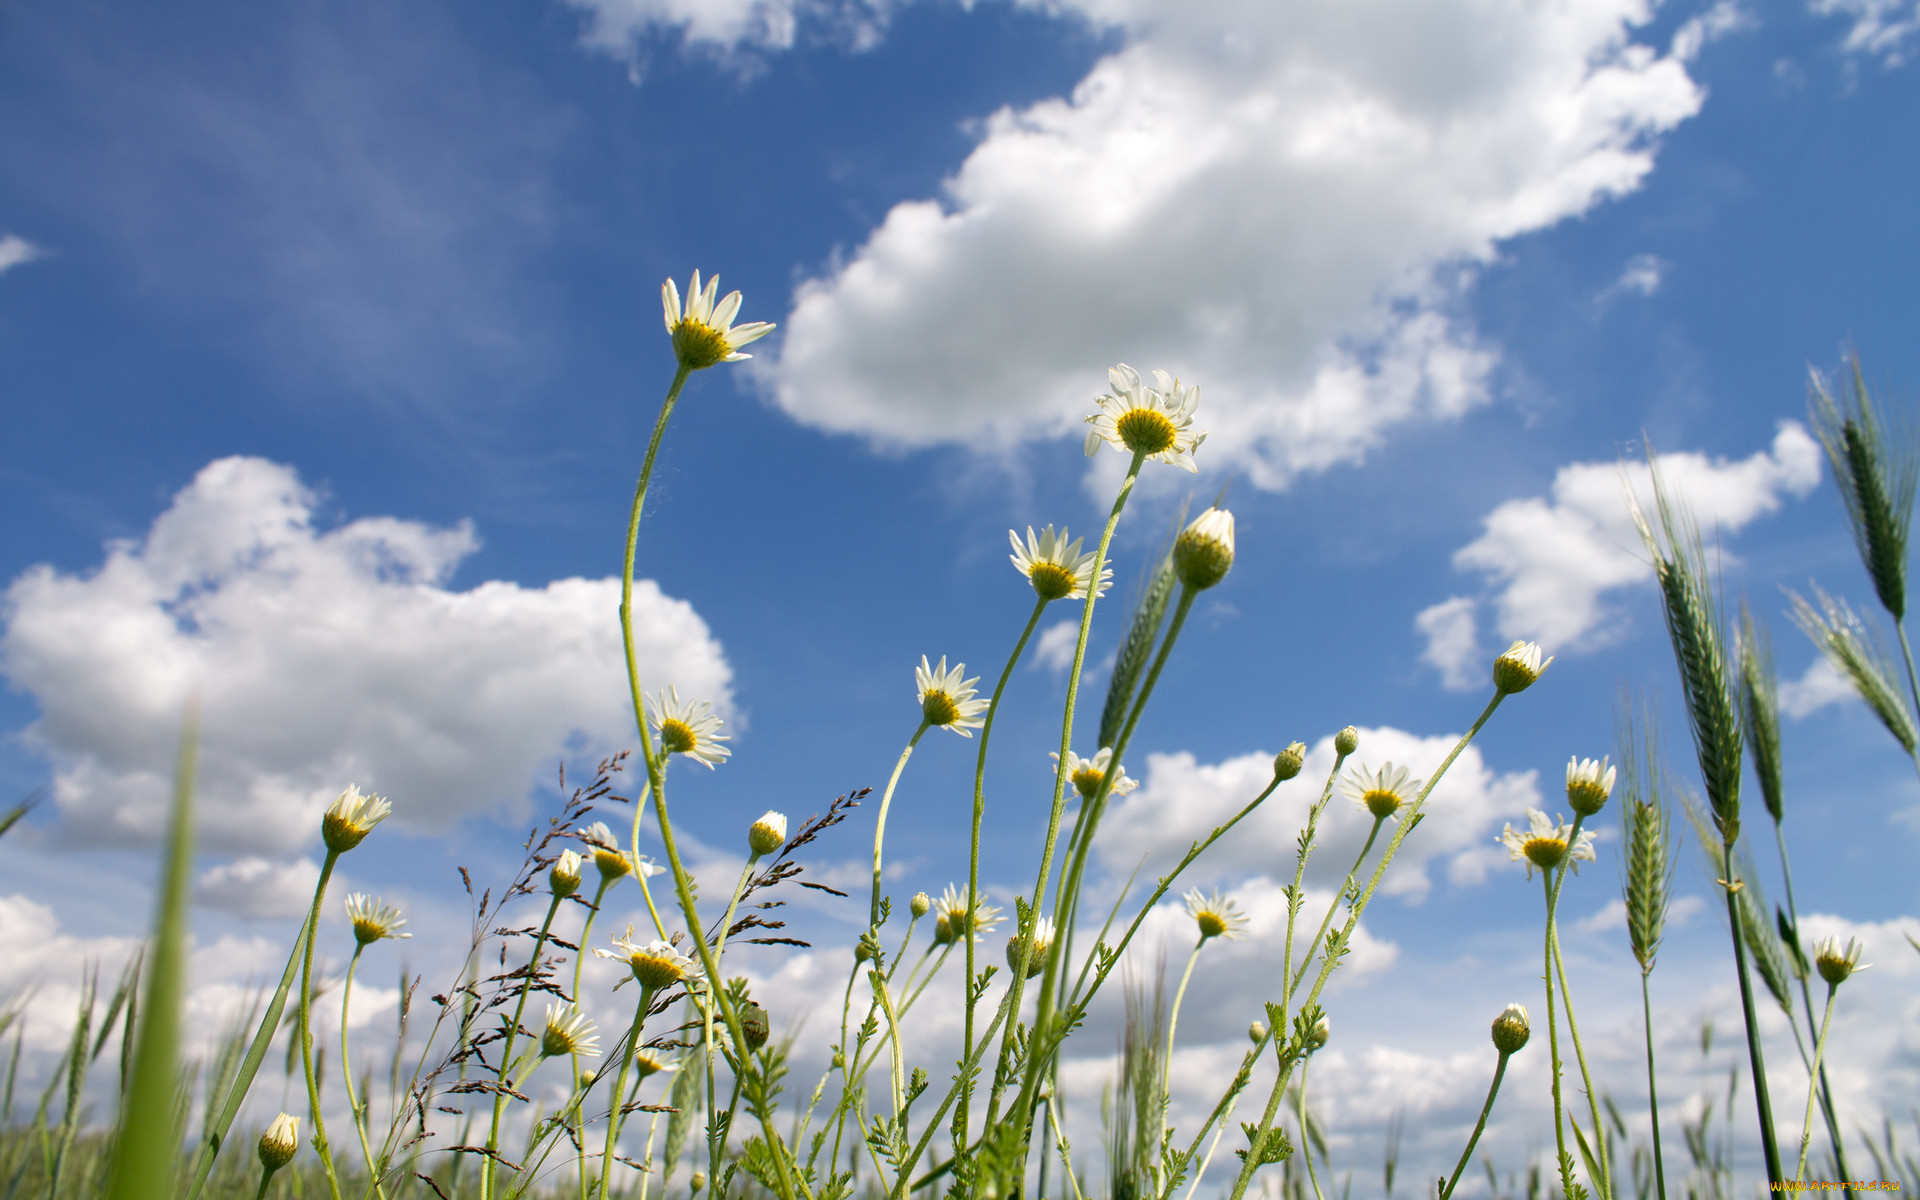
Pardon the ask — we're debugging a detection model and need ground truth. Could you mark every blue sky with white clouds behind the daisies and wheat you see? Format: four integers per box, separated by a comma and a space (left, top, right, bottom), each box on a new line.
0, 0, 1920, 1188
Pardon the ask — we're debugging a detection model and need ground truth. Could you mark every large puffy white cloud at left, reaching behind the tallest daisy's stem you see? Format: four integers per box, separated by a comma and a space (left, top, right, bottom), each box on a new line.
0, 457, 732, 852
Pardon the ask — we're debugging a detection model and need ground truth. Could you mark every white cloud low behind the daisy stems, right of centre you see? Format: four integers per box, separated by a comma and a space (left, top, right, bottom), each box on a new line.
1094, 728, 1540, 899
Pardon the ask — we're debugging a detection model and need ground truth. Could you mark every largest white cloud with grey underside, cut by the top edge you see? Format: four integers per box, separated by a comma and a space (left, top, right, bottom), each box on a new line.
729, 0, 1701, 488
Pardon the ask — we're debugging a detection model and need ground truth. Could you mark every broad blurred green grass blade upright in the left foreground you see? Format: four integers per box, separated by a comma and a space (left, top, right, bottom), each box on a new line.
108, 710, 200, 1200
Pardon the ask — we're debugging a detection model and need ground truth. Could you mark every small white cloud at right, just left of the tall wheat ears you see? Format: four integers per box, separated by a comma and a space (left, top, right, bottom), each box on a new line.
1415, 420, 1820, 687
